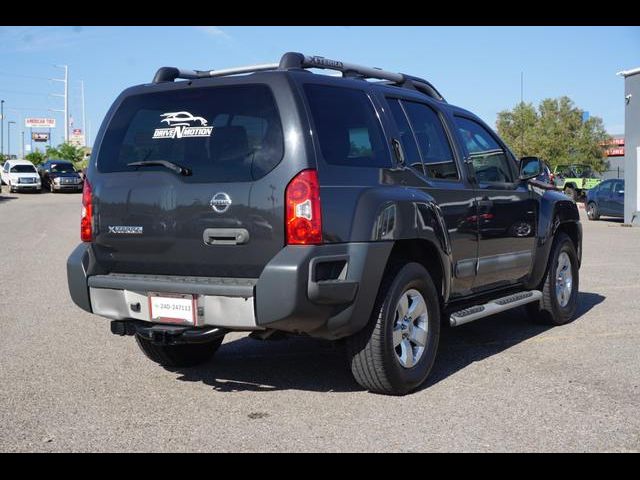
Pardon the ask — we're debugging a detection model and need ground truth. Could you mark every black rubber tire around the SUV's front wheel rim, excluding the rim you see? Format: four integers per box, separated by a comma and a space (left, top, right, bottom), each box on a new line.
527, 232, 580, 325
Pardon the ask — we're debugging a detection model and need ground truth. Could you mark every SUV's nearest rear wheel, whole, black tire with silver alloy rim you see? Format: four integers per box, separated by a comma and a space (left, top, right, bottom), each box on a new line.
347, 263, 440, 395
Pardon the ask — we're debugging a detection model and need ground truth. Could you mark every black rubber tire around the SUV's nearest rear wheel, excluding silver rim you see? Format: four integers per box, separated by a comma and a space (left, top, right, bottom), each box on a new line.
347, 263, 440, 395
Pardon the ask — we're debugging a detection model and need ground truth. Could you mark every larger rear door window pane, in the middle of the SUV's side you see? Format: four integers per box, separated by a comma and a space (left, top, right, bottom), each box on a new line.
402, 101, 460, 180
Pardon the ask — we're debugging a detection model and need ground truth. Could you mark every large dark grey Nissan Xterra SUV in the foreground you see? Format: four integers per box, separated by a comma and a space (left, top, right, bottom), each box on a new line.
67, 52, 582, 394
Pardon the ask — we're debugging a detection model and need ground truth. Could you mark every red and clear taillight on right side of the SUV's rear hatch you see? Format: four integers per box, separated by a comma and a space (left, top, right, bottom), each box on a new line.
285, 170, 322, 245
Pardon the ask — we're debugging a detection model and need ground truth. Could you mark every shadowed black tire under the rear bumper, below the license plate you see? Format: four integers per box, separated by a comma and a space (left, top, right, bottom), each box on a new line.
136, 335, 224, 367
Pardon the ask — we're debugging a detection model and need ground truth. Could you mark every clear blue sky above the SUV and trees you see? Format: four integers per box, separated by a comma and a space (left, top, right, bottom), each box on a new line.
0, 26, 640, 153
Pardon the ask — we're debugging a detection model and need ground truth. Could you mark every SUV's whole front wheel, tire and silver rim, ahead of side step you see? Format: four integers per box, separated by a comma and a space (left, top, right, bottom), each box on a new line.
527, 233, 580, 325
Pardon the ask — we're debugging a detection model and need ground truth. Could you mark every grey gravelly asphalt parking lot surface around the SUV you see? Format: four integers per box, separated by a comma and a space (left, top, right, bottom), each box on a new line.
0, 187, 640, 452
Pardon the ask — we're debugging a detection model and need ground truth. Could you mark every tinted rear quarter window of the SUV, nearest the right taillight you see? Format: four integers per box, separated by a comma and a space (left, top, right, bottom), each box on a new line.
304, 84, 391, 167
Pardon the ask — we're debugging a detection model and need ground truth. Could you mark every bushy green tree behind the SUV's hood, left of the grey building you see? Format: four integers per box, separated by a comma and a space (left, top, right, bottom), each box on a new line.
496, 97, 611, 172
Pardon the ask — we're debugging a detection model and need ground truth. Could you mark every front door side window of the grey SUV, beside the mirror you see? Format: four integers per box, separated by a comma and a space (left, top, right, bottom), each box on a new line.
455, 117, 513, 183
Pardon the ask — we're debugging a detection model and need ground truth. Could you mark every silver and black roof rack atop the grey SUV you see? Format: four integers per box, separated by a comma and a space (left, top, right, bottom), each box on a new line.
153, 52, 445, 102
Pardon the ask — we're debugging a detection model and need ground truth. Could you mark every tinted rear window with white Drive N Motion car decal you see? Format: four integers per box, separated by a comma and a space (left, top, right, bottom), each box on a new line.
98, 85, 284, 182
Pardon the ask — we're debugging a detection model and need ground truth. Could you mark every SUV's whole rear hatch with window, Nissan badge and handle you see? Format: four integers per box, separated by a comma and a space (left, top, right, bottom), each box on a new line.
91, 82, 284, 278
